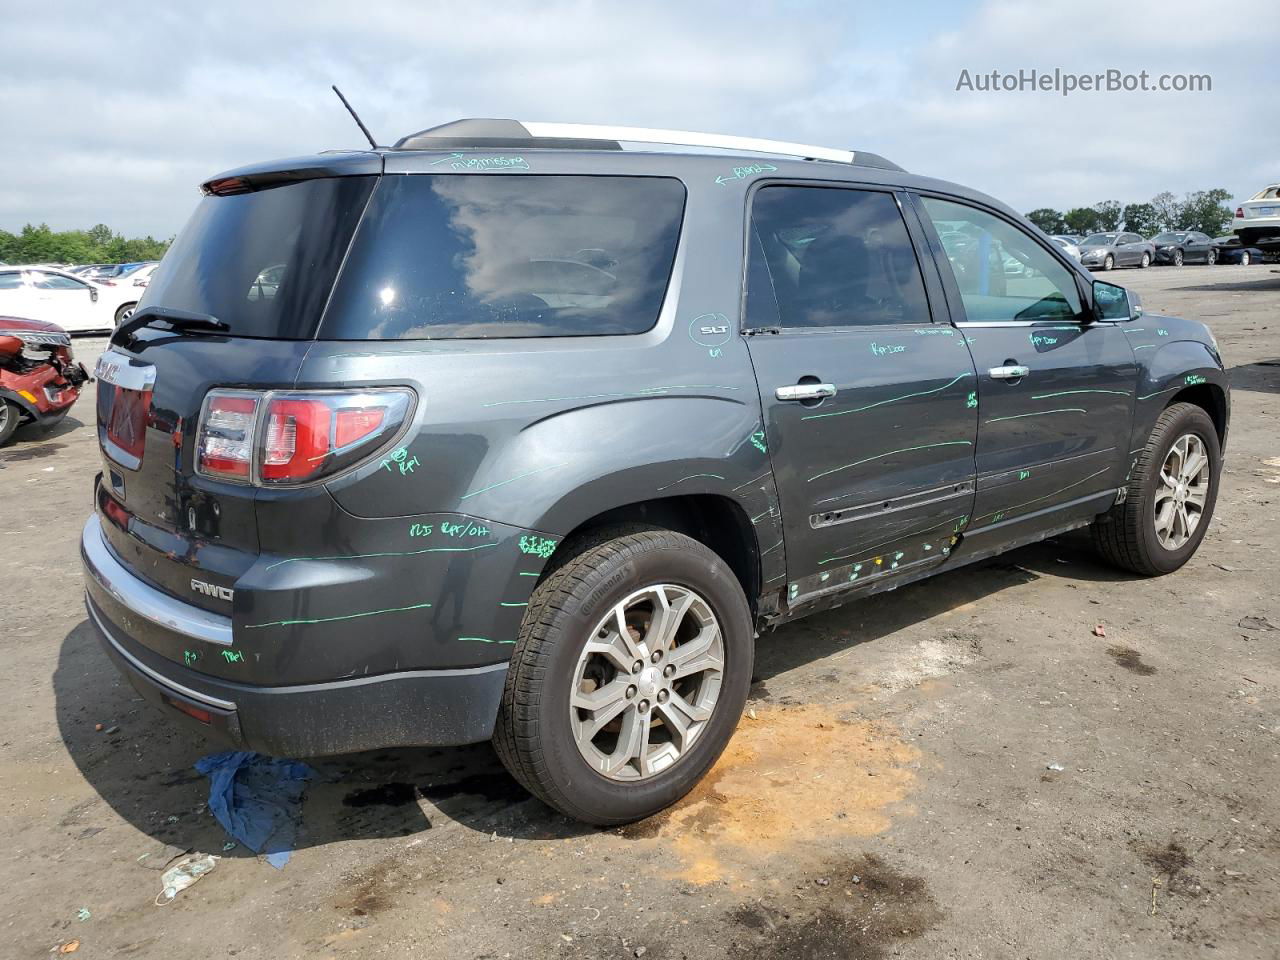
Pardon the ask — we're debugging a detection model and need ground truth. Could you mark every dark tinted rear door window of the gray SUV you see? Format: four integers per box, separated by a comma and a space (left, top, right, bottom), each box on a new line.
746, 186, 929, 326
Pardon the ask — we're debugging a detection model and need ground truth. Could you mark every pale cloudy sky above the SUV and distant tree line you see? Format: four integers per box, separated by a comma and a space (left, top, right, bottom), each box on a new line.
0, 0, 1280, 237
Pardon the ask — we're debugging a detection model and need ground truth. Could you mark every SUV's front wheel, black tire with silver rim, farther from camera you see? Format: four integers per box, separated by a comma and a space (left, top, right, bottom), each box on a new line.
1092, 403, 1222, 576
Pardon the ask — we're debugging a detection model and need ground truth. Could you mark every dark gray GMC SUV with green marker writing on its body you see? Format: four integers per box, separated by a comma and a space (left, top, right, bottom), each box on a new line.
82, 120, 1229, 824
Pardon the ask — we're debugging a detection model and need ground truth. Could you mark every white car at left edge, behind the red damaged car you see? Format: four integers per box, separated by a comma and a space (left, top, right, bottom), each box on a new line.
0, 266, 142, 333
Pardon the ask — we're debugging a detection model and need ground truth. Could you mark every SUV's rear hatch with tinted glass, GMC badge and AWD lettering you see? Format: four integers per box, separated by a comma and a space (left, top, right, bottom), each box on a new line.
97, 172, 376, 614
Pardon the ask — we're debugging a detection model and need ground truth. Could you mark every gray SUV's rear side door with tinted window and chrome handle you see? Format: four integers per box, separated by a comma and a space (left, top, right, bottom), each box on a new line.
744, 184, 977, 604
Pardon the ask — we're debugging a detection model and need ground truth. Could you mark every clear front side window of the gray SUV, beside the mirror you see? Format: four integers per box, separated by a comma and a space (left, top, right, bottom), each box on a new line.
924, 197, 1085, 320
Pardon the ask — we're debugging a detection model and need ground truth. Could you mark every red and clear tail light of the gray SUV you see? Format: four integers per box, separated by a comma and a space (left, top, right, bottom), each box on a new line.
196, 388, 413, 486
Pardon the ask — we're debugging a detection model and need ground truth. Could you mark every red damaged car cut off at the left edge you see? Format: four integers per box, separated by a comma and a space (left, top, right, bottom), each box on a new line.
0, 316, 88, 447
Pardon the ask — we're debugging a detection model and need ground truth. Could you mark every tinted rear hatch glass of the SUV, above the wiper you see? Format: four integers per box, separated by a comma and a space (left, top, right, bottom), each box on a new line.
138, 177, 374, 339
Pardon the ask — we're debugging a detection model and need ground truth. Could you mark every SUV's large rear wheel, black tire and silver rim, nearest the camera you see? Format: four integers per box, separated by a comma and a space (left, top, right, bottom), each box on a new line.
494, 526, 754, 826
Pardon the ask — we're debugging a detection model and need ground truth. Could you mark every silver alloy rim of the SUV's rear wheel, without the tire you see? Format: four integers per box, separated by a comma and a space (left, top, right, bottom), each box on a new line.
568, 584, 724, 782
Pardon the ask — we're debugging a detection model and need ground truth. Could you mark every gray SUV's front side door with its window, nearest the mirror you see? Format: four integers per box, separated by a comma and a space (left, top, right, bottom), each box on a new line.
916, 197, 1137, 549
